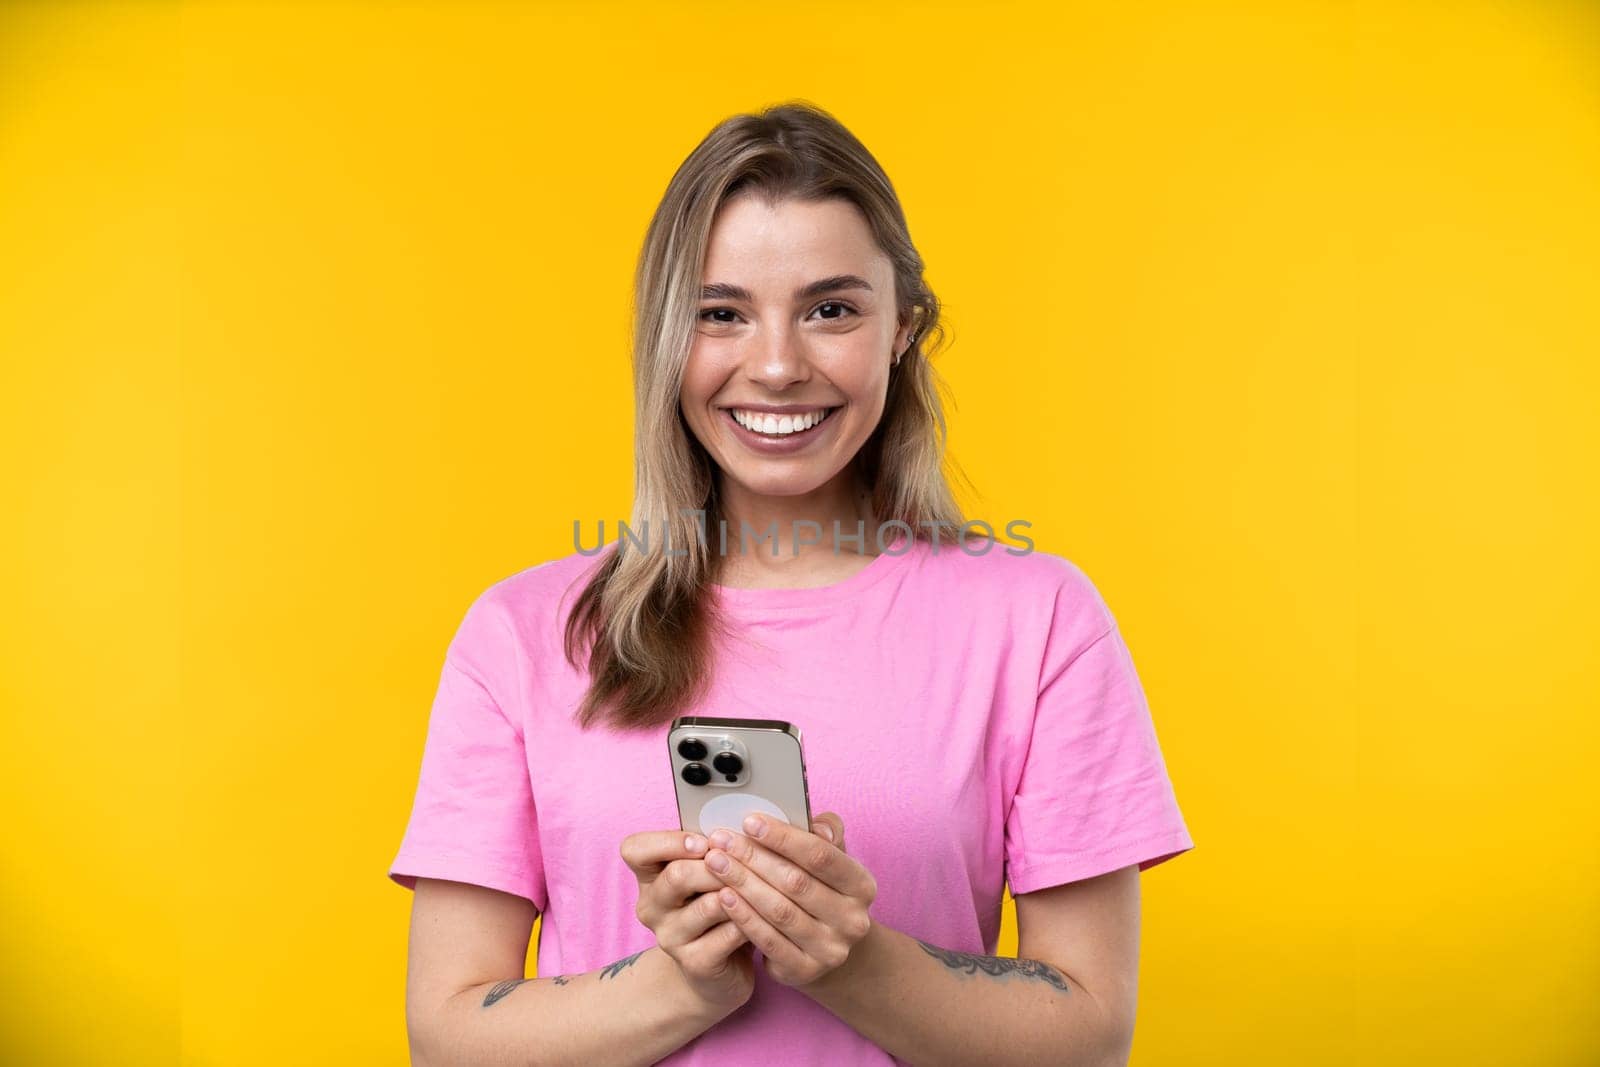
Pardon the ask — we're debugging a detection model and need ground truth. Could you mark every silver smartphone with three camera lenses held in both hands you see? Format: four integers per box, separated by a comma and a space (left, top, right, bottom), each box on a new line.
667, 715, 811, 833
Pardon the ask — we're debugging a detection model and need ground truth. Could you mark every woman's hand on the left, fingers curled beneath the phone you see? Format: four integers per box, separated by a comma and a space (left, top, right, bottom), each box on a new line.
621, 830, 755, 1014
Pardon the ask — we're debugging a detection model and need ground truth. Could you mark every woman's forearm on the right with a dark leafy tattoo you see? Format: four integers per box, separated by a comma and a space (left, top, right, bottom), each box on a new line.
802, 923, 1126, 1067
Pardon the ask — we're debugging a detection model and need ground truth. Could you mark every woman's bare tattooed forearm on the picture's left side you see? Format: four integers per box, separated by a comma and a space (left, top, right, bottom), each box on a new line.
411, 947, 723, 1067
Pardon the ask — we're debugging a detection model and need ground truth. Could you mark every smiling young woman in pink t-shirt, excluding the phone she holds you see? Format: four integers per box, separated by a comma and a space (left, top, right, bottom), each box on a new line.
389, 104, 1194, 1067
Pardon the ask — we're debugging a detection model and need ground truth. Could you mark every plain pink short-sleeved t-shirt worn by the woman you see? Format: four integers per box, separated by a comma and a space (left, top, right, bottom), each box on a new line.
389, 539, 1194, 1067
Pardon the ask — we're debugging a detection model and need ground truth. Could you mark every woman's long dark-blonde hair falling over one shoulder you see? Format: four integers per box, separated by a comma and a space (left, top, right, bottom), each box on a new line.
565, 101, 965, 729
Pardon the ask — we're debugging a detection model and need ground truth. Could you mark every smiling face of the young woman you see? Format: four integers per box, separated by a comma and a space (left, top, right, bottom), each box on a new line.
680, 195, 910, 496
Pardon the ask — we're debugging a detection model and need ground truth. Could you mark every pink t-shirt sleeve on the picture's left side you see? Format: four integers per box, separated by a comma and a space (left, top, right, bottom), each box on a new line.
389, 595, 547, 913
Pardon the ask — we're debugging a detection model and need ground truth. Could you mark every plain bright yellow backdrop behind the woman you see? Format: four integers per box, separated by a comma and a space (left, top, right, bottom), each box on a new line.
0, 2, 1600, 1065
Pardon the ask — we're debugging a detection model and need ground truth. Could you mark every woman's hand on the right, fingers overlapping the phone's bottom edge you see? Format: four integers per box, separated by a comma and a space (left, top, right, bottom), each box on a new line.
706, 811, 878, 987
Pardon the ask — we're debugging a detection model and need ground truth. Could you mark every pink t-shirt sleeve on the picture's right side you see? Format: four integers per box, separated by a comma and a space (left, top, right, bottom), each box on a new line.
1005, 571, 1194, 896
